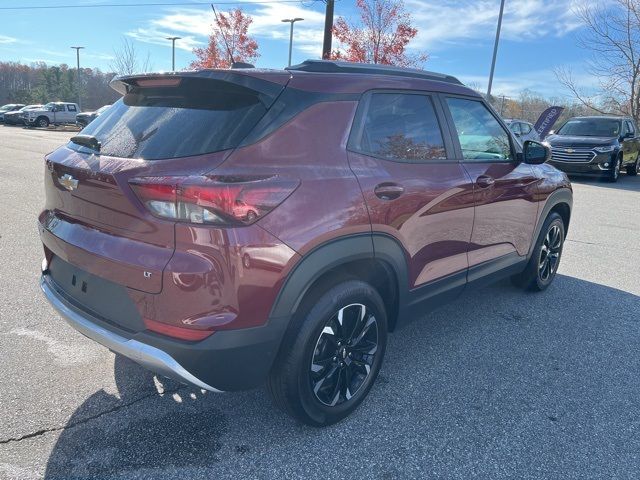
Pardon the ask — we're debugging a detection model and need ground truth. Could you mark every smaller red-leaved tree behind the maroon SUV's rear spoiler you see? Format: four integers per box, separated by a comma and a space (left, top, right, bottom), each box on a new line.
191, 8, 260, 68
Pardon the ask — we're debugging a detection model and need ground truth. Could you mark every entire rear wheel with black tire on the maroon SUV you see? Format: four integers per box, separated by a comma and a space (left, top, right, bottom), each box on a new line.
267, 280, 387, 427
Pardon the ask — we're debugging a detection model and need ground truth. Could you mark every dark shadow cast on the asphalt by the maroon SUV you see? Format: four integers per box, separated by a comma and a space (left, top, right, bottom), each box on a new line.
45, 275, 640, 479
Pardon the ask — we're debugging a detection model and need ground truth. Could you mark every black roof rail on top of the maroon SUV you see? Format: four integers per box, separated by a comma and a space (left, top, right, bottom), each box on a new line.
285, 60, 463, 85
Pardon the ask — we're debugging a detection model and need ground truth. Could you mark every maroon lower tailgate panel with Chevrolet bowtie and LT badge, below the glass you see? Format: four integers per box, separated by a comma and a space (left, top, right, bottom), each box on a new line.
40, 147, 208, 293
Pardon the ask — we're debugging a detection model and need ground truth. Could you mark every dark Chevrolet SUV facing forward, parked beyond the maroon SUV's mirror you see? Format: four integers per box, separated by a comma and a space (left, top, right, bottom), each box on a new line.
546, 116, 640, 182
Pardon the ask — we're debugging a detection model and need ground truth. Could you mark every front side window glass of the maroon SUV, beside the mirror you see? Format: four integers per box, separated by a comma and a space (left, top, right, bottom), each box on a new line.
447, 98, 512, 161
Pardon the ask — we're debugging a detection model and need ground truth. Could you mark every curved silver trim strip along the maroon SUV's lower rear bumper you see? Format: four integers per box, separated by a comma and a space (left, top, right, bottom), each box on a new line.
40, 275, 222, 392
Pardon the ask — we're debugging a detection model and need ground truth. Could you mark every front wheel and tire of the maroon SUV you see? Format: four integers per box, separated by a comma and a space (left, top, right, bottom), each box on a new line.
511, 212, 565, 292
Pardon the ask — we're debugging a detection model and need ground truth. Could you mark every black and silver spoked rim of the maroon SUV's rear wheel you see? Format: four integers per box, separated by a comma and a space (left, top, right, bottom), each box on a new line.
310, 304, 378, 407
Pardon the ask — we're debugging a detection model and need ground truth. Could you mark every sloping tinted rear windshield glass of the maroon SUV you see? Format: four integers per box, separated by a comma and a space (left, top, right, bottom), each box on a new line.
69, 78, 266, 160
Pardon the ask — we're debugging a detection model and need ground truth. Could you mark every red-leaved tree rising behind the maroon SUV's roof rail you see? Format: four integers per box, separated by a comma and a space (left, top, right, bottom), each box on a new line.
331, 0, 428, 67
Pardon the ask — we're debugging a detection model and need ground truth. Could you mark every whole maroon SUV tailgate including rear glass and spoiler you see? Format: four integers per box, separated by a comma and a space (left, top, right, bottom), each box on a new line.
40, 71, 288, 293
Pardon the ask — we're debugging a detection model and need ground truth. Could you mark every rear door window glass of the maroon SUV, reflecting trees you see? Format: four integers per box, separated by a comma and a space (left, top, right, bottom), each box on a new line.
358, 93, 447, 163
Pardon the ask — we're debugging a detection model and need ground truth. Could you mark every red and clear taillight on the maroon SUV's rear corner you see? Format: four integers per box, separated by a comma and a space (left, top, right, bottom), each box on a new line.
129, 176, 299, 225
